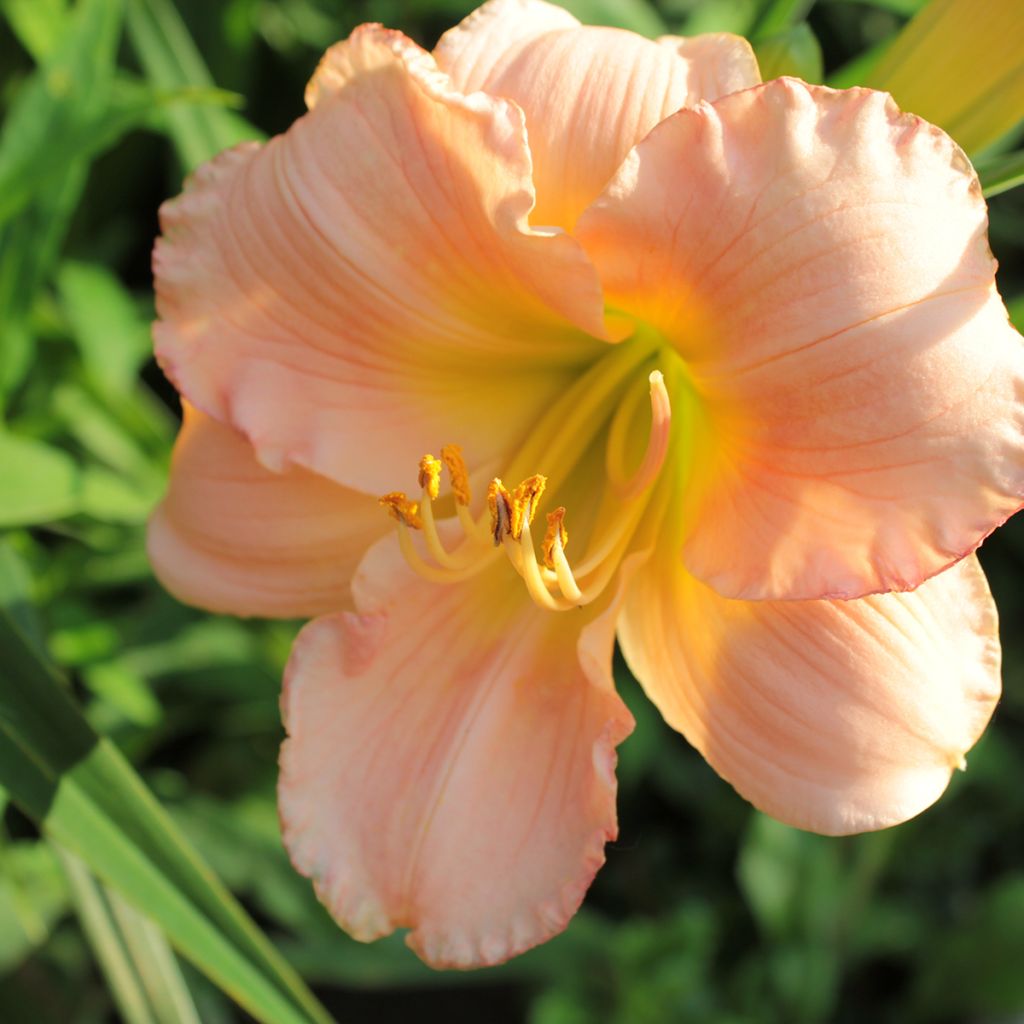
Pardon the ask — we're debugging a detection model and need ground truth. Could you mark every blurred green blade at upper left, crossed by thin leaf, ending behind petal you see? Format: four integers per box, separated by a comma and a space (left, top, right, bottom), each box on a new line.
127, 0, 262, 171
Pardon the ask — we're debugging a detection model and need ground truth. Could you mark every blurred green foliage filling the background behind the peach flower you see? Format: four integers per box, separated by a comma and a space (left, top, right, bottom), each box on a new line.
0, 0, 1024, 1024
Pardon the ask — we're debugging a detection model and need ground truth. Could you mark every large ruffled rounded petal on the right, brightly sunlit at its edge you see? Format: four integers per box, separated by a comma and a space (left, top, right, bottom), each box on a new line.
579, 79, 1024, 598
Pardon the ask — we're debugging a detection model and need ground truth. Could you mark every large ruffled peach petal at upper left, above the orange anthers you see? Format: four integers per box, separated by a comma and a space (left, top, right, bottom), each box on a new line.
155, 26, 604, 493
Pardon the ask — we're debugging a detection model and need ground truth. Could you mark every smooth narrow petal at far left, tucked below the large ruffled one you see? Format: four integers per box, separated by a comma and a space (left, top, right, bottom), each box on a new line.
147, 406, 382, 617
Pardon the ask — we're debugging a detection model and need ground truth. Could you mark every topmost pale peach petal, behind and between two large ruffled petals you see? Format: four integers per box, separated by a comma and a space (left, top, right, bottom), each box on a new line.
434, 0, 761, 229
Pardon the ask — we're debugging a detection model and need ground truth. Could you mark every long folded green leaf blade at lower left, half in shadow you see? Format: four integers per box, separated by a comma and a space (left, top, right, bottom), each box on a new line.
0, 611, 330, 1024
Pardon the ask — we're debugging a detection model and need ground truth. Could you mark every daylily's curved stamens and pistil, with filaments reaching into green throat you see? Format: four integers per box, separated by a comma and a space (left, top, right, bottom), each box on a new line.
380, 332, 679, 611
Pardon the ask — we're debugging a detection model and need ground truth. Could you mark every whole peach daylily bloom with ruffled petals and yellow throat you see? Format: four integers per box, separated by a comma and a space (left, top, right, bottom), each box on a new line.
150, 0, 1024, 967
